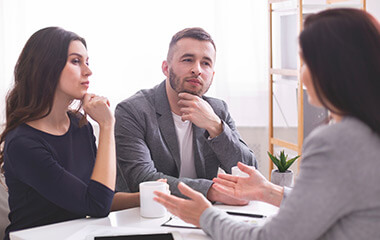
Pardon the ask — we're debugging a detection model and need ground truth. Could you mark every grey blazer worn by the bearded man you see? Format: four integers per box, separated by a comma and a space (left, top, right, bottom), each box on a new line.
115, 81, 256, 196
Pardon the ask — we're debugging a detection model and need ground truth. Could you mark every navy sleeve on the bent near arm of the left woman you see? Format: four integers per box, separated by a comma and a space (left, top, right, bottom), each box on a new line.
6, 137, 114, 217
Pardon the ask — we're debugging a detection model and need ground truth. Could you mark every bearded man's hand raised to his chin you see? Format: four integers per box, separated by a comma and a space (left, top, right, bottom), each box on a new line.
178, 93, 223, 138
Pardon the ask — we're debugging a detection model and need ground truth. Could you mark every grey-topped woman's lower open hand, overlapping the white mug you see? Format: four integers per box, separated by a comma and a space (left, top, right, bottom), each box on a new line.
154, 182, 211, 227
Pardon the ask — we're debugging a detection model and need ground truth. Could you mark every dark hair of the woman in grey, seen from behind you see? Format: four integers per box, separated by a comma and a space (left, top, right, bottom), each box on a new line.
299, 8, 380, 134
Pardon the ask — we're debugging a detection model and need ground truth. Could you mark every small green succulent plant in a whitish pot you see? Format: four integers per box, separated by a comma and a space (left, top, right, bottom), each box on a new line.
268, 150, 300, 187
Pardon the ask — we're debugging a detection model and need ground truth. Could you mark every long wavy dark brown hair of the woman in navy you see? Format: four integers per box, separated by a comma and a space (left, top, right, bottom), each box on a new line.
0, 27, 86, 172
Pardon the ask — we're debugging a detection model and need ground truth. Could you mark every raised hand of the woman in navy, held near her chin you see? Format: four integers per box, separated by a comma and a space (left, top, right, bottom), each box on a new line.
83, 94, 115, 126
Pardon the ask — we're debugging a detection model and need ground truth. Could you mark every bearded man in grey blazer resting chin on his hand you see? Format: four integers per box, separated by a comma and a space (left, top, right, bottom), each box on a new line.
115, 28, 256, 204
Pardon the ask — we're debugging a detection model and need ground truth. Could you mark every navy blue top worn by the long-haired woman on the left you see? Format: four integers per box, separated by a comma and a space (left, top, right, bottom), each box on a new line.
4, 113, 114, 239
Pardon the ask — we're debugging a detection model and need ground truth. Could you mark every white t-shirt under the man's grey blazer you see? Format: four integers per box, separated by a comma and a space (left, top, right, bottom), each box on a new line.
172, 112, 197, 178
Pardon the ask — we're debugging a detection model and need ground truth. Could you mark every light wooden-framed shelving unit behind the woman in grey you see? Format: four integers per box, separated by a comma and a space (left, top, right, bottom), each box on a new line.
268, 0, 366, 176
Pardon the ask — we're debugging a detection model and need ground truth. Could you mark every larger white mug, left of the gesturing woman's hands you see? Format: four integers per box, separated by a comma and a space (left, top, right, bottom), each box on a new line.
139, 181, 169, 218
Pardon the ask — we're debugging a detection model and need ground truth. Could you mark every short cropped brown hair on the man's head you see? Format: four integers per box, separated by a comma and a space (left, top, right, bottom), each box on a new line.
167, 27, 216, 61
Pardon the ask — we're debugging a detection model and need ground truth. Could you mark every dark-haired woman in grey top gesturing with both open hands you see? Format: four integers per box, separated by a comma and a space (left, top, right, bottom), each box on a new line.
156, 9, 380, 240
